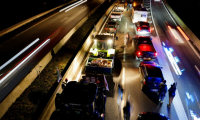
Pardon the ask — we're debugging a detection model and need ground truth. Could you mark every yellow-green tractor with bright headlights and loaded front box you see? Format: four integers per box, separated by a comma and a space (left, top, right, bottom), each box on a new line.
85, 33, 115, 73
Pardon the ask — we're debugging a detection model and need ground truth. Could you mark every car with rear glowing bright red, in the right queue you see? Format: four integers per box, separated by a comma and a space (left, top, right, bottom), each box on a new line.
135, 37, 158, 60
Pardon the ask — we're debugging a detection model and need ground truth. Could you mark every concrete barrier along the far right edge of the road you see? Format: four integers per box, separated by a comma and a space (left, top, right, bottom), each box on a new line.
163, 0, 200, 50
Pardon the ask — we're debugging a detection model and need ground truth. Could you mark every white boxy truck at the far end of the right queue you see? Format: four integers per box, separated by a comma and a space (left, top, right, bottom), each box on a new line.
131, 4, 148, 23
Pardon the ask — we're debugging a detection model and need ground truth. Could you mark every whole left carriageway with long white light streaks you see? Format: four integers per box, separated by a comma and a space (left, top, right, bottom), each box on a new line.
0, 0, 104, 101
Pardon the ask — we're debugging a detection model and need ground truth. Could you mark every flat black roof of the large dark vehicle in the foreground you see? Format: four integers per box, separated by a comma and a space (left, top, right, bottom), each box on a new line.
61, 81, 98, 105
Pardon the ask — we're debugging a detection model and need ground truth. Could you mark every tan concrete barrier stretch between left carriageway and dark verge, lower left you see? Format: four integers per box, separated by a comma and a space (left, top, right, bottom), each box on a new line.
0, 52, 52, 118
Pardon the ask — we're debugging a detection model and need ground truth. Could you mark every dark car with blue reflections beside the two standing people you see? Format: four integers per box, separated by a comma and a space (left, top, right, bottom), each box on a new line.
139, 61, 164, 93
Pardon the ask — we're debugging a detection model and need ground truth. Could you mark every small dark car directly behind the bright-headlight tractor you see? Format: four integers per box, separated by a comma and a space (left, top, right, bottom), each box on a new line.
105, 21, 119, 33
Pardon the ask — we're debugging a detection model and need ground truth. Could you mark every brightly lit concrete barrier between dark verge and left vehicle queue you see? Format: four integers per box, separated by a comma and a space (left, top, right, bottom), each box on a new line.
39, 3, 115, 120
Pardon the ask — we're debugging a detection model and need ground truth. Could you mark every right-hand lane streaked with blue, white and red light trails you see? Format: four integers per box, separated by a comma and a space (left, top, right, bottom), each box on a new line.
153, 0, 200, 119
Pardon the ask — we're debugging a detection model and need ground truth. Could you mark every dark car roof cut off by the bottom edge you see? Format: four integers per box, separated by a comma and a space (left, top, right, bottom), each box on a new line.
137, 112, 170, 120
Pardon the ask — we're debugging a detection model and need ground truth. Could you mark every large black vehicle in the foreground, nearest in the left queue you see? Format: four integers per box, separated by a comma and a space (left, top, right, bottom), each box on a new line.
51, 74, 109, 120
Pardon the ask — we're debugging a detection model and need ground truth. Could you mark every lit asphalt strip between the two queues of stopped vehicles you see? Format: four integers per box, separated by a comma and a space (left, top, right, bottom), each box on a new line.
111, 7, 177, 120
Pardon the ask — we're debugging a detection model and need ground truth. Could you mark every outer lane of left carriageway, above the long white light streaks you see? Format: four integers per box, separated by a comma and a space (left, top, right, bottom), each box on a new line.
0, 0, 102, 67
